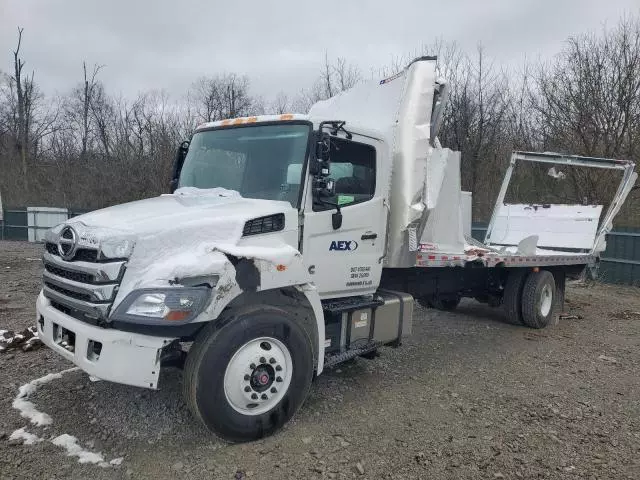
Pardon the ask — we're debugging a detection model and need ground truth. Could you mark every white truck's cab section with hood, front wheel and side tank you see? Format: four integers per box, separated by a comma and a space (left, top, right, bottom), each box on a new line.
37, 106, 413, 441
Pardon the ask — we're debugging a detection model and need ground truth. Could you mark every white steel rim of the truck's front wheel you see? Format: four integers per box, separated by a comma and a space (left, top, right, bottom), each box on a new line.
224, 337, 293, 415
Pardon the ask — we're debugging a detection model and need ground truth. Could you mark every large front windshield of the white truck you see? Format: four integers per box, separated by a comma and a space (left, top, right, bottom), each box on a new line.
178, 123, 311, 207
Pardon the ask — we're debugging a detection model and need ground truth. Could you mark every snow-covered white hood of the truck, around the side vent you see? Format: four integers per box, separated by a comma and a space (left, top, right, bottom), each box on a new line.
48, 188, 300, 308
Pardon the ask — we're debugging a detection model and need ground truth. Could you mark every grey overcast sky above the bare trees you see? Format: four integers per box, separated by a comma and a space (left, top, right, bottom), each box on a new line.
0, 0, 640, 100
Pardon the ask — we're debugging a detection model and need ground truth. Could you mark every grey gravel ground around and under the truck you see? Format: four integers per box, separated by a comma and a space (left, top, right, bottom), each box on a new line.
0, 242, 640, 479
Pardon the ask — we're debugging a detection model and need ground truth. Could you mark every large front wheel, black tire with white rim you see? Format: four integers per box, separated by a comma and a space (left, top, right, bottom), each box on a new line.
184, 305, 314, 442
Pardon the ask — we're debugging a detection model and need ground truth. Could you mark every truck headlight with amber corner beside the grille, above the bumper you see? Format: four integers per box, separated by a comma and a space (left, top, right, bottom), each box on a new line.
111, 287, 211, 325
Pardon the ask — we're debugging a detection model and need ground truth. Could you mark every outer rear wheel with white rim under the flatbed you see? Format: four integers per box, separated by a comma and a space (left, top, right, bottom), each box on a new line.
522, 270, 557, 328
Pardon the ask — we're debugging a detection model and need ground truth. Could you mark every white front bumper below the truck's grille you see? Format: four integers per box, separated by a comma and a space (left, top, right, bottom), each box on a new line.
36, 292, 175, 389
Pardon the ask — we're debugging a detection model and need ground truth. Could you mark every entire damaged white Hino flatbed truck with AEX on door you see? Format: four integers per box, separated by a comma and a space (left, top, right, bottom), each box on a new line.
37, 57, 637, 441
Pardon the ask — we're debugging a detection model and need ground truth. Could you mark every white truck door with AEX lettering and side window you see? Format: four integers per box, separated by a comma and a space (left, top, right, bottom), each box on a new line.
301, 136, 387, 298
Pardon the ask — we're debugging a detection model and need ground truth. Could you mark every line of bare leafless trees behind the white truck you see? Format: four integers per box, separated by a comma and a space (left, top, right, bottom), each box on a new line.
0, 17, 640, 226
